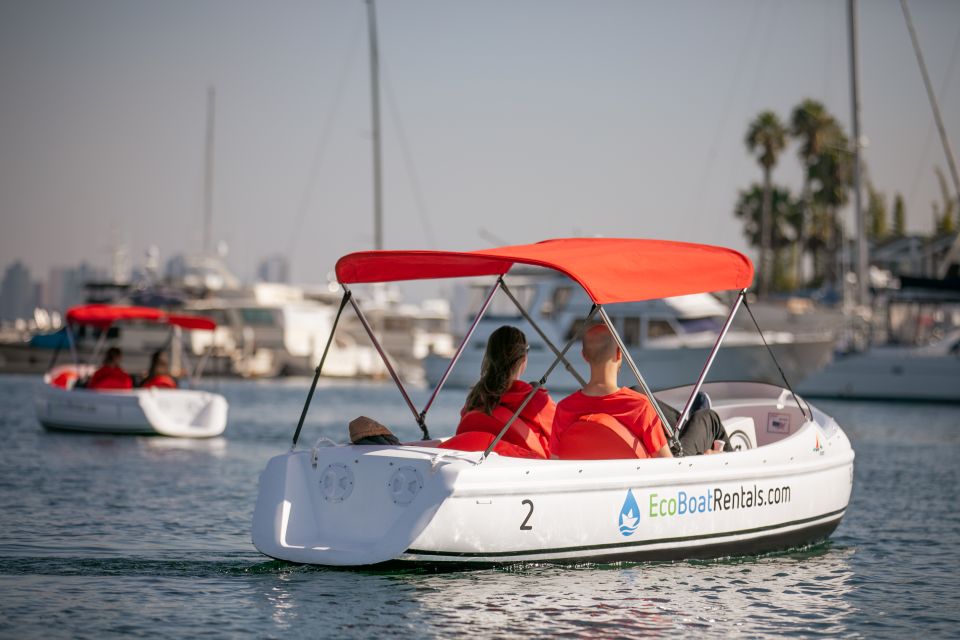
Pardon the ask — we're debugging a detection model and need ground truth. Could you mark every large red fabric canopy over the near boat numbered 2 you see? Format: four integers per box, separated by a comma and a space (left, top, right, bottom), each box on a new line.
337, 238, 753, 304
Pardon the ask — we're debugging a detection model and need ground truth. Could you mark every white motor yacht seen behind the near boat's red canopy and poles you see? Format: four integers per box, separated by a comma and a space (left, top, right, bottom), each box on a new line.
424, 274, 833, 390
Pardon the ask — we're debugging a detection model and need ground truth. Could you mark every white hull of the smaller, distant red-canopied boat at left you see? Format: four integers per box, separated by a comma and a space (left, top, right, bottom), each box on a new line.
34, 383, 227, 438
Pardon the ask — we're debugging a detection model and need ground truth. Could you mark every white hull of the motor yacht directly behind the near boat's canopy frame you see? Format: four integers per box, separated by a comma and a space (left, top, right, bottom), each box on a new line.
423, 336, 833, 390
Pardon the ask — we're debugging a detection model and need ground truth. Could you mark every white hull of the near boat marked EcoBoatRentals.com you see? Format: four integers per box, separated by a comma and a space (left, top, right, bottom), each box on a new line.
253, 383, 854, 566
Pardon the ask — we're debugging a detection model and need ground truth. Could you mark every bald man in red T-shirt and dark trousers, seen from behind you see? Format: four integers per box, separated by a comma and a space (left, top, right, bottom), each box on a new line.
550, 324, 733, 458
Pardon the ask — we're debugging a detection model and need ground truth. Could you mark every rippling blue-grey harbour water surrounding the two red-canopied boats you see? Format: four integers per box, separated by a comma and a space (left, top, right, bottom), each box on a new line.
0, 376, 960, 638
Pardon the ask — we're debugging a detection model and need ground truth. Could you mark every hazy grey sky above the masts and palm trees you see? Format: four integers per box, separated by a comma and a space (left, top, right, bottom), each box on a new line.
0, 0, 960, 282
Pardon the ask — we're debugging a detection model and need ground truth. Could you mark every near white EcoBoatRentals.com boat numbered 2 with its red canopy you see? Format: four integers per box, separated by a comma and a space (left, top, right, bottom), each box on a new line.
252, 239, 854, 566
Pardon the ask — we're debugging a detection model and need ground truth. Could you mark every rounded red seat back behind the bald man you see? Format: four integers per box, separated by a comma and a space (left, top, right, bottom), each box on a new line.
556, 413, 649, 460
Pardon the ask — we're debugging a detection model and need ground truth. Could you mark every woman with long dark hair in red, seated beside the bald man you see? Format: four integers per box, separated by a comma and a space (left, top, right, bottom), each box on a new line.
441, 325, 556, 458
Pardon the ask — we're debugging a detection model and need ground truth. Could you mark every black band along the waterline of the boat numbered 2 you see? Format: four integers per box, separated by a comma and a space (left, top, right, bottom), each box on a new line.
404, 507, 846, 560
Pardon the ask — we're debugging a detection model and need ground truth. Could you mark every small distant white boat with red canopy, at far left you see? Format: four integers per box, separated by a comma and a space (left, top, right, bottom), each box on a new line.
34, 305, 227, 438
